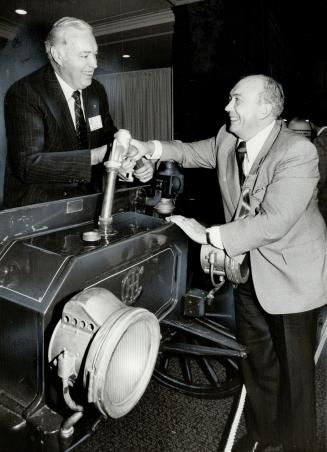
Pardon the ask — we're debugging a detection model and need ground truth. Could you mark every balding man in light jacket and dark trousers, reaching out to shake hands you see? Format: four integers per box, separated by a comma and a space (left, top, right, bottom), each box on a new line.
131, 75, 327, 452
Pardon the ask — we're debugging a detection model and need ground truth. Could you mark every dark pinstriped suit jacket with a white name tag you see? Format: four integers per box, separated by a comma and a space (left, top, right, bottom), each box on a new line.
4, 64, 116, 207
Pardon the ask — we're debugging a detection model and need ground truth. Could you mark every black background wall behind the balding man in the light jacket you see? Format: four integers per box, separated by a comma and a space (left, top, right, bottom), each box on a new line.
173, 0, 327, 223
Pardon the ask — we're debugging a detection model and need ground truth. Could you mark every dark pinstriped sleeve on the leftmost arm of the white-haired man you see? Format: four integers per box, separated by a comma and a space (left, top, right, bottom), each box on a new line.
5, 83, 91, 184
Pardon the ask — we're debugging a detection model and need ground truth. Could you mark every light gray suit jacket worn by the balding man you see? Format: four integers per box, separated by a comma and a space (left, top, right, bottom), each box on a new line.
162, 121, 327, 314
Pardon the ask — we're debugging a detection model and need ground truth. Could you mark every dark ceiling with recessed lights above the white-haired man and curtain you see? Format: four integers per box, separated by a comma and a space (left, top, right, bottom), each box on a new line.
0, 0, 202, 72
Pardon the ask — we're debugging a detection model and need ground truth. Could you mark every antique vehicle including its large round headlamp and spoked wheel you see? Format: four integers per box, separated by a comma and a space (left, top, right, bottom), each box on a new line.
0, 182, 244, 451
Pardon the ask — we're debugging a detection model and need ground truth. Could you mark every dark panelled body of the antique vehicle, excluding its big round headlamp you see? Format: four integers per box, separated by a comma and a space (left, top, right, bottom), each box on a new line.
0, 188, 187, 450
